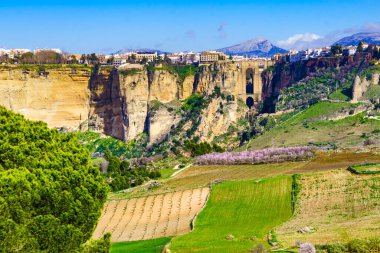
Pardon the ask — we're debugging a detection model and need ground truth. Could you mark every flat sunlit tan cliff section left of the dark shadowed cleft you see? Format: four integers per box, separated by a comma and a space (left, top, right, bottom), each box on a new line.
0, 67, 90, 129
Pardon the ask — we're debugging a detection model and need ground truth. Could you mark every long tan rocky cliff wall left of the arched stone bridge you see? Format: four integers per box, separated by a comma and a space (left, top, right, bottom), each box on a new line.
0, 63, 248, 144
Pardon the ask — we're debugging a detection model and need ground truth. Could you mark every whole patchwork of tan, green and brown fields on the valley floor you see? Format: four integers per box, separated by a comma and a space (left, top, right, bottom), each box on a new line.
95, 150, 380, 252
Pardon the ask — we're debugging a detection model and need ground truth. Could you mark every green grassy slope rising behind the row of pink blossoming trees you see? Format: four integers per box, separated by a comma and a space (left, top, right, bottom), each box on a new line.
240, 102, 380, 150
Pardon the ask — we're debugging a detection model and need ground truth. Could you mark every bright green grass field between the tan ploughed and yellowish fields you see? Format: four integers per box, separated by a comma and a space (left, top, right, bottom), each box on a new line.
170, 176, 292, 253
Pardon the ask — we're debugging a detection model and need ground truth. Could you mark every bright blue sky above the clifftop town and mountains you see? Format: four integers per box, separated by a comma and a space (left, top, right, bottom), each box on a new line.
0, 0, 380, 53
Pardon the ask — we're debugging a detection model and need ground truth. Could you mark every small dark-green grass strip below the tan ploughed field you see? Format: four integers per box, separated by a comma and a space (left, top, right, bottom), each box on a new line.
111, 238, 170, 253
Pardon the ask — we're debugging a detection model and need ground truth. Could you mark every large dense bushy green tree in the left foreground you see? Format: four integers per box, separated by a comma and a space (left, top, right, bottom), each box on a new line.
0, 107, 109, 252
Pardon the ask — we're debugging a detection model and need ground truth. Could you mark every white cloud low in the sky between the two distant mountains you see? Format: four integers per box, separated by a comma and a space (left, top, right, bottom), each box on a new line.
277, 33, 324, 49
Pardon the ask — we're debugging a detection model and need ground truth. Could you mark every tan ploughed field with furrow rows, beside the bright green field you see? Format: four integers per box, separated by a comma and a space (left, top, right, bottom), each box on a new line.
93, 187, 209, 242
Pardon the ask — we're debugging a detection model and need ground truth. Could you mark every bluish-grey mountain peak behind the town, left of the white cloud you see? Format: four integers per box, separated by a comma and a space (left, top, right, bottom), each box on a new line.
216, 39, 287, 57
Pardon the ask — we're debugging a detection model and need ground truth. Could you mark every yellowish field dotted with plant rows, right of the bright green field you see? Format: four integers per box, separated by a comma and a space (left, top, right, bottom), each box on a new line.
276, 170, 380, 247
